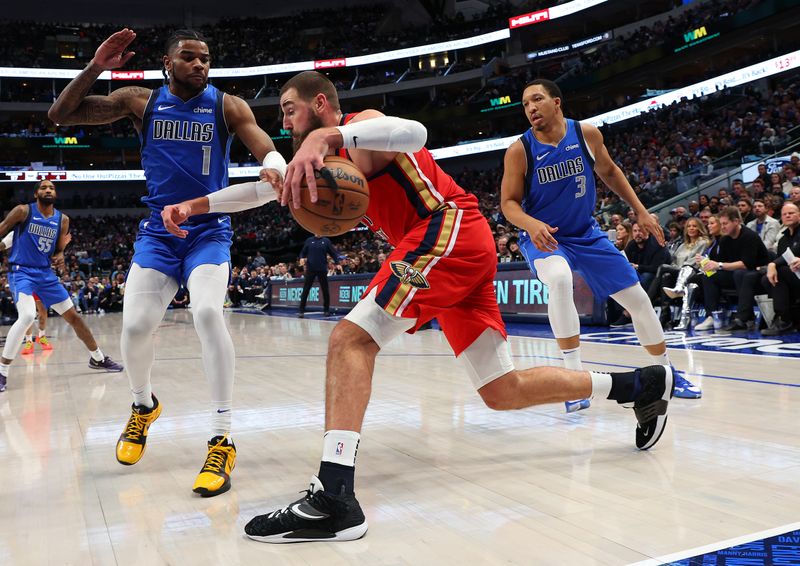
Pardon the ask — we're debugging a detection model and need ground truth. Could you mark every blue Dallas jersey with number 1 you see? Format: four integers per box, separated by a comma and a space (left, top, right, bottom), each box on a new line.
139, 85, 233, 217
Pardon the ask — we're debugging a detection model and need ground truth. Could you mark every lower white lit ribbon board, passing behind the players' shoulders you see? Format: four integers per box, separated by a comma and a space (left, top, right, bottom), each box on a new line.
0, 50, 800, 182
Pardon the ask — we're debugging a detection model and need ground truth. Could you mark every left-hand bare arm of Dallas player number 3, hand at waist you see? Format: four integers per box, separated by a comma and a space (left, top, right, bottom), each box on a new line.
500, 141, 558, 252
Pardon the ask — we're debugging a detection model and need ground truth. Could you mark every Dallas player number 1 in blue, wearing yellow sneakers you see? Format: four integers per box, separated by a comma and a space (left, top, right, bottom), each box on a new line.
49, 28, 286, 497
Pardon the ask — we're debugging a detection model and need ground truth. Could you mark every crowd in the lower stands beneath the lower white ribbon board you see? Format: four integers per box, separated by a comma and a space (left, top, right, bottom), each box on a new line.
0, 67, 800, 336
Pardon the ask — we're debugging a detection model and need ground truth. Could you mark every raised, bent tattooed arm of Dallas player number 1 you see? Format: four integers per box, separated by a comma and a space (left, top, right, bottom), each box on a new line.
47, 28, 151, 125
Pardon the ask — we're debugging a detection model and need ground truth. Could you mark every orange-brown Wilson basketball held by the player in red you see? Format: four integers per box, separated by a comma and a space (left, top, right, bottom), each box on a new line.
289, 155, 369, 236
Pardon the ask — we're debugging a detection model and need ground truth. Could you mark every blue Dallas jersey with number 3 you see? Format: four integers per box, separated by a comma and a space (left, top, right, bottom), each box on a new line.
520, 119, 597, 241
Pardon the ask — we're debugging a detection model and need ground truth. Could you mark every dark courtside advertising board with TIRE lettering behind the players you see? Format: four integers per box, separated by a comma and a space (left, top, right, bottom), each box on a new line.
272, 263, 603, 323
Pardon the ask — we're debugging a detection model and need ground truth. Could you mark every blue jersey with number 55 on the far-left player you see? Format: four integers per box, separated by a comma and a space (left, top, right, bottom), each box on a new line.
8, 202, 61, 269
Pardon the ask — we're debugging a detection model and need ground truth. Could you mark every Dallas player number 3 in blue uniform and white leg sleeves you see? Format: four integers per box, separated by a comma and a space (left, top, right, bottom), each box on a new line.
500, 79, 701, 412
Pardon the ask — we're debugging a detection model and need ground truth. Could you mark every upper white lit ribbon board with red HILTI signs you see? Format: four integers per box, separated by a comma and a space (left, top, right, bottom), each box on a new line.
0, 0, 608, 81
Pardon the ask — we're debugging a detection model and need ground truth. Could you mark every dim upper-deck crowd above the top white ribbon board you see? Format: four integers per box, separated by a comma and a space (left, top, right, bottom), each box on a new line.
0, 2, 516, 69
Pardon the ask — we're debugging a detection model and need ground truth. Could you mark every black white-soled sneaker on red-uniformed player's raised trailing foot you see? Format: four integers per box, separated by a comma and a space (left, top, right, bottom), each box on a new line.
633, 366, 675, 450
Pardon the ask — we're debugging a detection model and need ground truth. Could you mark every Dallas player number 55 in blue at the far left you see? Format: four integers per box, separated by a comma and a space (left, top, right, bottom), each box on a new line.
0, 181, 122, 391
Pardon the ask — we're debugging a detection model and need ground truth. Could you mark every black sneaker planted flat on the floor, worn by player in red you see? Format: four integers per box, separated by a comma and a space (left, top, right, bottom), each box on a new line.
244, 476, 367, 544
